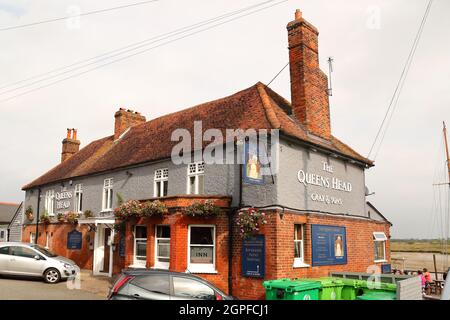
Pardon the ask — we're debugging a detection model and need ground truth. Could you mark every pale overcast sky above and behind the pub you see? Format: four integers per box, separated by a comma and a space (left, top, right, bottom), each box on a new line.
0, 0, 450, 237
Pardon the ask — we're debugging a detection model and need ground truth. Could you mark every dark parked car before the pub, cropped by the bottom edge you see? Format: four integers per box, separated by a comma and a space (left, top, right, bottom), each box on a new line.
108, 269, 234, 300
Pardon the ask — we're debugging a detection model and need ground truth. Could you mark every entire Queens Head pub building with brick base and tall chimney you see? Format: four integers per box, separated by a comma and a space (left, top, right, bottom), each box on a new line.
23, 10, 391, 299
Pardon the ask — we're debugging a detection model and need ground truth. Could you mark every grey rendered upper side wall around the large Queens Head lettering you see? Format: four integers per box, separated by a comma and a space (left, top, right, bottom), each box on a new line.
277, 140, 367, 216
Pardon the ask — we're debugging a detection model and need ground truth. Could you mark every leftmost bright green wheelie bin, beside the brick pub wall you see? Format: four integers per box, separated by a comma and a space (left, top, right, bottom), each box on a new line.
263, 279, 320, 300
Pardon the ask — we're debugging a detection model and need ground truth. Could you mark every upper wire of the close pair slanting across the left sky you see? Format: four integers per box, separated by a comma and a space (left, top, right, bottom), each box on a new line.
0, 0, 275, 95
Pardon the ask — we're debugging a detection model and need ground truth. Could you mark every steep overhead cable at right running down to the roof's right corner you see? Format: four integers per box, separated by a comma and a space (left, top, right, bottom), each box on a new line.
367, 0, 434, 160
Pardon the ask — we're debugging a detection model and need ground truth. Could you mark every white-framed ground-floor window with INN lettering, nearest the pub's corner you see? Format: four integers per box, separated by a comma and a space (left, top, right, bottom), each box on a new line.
188, 225, 216, 273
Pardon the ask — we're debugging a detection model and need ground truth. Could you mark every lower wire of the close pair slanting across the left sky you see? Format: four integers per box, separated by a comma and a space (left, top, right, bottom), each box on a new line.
0, 0, 289, 102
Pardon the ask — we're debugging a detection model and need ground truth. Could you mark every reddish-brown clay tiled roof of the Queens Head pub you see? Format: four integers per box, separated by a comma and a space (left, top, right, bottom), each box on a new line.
23, 82, 373, 190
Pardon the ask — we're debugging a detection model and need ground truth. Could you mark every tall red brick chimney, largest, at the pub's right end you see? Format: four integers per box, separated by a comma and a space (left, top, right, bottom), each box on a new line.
287, 10, 331, 139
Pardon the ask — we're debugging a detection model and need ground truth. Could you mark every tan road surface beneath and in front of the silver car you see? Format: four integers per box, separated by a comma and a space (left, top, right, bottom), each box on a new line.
0, 270, 112, 300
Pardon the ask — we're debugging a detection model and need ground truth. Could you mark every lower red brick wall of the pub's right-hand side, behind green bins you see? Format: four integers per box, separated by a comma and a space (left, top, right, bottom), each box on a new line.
233, 212, 390, 299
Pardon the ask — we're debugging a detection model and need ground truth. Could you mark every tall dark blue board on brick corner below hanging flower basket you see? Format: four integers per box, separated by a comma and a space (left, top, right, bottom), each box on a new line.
242, 235, 266, 278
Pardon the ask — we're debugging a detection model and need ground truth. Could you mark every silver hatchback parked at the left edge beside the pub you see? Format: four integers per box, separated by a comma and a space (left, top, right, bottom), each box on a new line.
0, 242, 80, 283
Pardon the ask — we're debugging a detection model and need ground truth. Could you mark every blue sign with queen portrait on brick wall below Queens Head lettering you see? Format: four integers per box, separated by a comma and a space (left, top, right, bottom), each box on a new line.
311, 224, 347, 266
